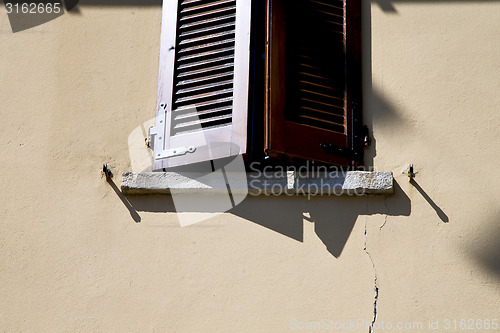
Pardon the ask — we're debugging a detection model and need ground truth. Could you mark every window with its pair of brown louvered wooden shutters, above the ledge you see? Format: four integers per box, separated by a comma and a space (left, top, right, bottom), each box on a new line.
150, 0, 366, 170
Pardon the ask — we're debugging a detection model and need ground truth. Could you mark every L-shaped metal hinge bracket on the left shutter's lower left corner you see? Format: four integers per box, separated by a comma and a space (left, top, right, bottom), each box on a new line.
148, 103, 196, 160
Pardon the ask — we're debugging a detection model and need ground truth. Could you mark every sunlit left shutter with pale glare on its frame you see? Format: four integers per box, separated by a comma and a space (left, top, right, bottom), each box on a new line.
150, 0, 251, 170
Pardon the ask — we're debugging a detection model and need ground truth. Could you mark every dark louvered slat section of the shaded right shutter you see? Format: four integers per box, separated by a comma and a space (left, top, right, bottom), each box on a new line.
287, 0, 346, 133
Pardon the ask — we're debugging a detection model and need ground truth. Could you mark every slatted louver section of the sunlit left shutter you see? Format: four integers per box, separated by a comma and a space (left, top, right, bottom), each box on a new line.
171, 0, 236, 135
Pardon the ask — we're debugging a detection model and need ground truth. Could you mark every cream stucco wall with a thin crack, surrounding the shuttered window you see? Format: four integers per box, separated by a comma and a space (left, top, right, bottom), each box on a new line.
0, 0, 500, 332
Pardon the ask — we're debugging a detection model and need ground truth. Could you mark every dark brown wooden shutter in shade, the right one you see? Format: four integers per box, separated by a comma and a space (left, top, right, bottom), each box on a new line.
266, 0, 364, 166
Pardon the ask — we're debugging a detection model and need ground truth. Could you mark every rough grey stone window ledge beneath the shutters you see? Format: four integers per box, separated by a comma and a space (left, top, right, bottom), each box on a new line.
121, 171, 394, 196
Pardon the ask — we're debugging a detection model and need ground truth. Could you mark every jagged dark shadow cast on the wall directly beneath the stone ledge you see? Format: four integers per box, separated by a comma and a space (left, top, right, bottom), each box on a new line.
128, 183, 411, 257
